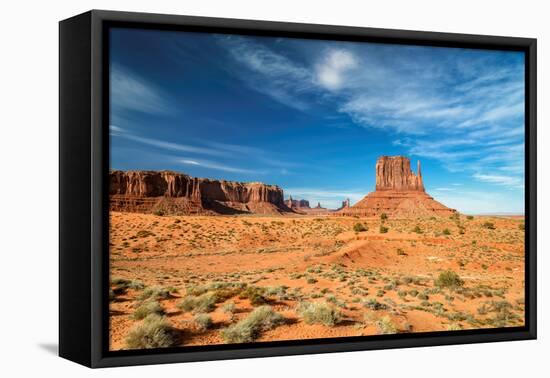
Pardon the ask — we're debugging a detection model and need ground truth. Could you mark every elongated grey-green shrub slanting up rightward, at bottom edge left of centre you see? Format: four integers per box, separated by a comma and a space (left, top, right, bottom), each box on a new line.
220, 305, 285, 343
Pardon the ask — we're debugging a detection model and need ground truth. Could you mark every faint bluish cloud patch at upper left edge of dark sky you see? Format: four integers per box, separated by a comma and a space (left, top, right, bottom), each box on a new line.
110, 63, 171, 114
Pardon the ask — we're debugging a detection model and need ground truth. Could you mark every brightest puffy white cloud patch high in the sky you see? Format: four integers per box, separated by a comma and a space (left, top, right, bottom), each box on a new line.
316, 49, 357, 91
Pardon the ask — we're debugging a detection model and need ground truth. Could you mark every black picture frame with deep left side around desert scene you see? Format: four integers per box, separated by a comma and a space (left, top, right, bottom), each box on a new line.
59, 10, 537, 368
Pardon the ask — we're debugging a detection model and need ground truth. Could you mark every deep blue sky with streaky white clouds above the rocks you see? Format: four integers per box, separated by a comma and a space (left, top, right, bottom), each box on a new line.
110, 29, 524, 214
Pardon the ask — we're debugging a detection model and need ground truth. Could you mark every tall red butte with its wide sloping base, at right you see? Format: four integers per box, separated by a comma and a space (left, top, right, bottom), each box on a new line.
338, 156, 456, 217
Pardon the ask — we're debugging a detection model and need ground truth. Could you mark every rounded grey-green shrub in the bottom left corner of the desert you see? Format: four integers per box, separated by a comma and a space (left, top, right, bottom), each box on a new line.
126, 314, 179, 349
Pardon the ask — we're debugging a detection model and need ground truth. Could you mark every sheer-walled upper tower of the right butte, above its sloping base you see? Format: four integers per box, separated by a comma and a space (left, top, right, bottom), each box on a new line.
376, 156, 424, 192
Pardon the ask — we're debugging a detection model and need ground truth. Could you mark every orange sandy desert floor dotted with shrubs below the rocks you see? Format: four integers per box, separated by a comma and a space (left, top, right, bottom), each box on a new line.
110, 212, 525, 350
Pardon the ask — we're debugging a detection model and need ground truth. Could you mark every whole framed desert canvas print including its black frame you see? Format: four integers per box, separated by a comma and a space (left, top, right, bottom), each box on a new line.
59, 11, 536, 367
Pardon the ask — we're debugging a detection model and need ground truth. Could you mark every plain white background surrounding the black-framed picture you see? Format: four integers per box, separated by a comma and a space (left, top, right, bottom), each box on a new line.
0, 0, 550, 378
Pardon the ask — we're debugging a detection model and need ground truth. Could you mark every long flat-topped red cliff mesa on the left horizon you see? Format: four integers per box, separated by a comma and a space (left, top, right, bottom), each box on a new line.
109, 171, 291, 214
